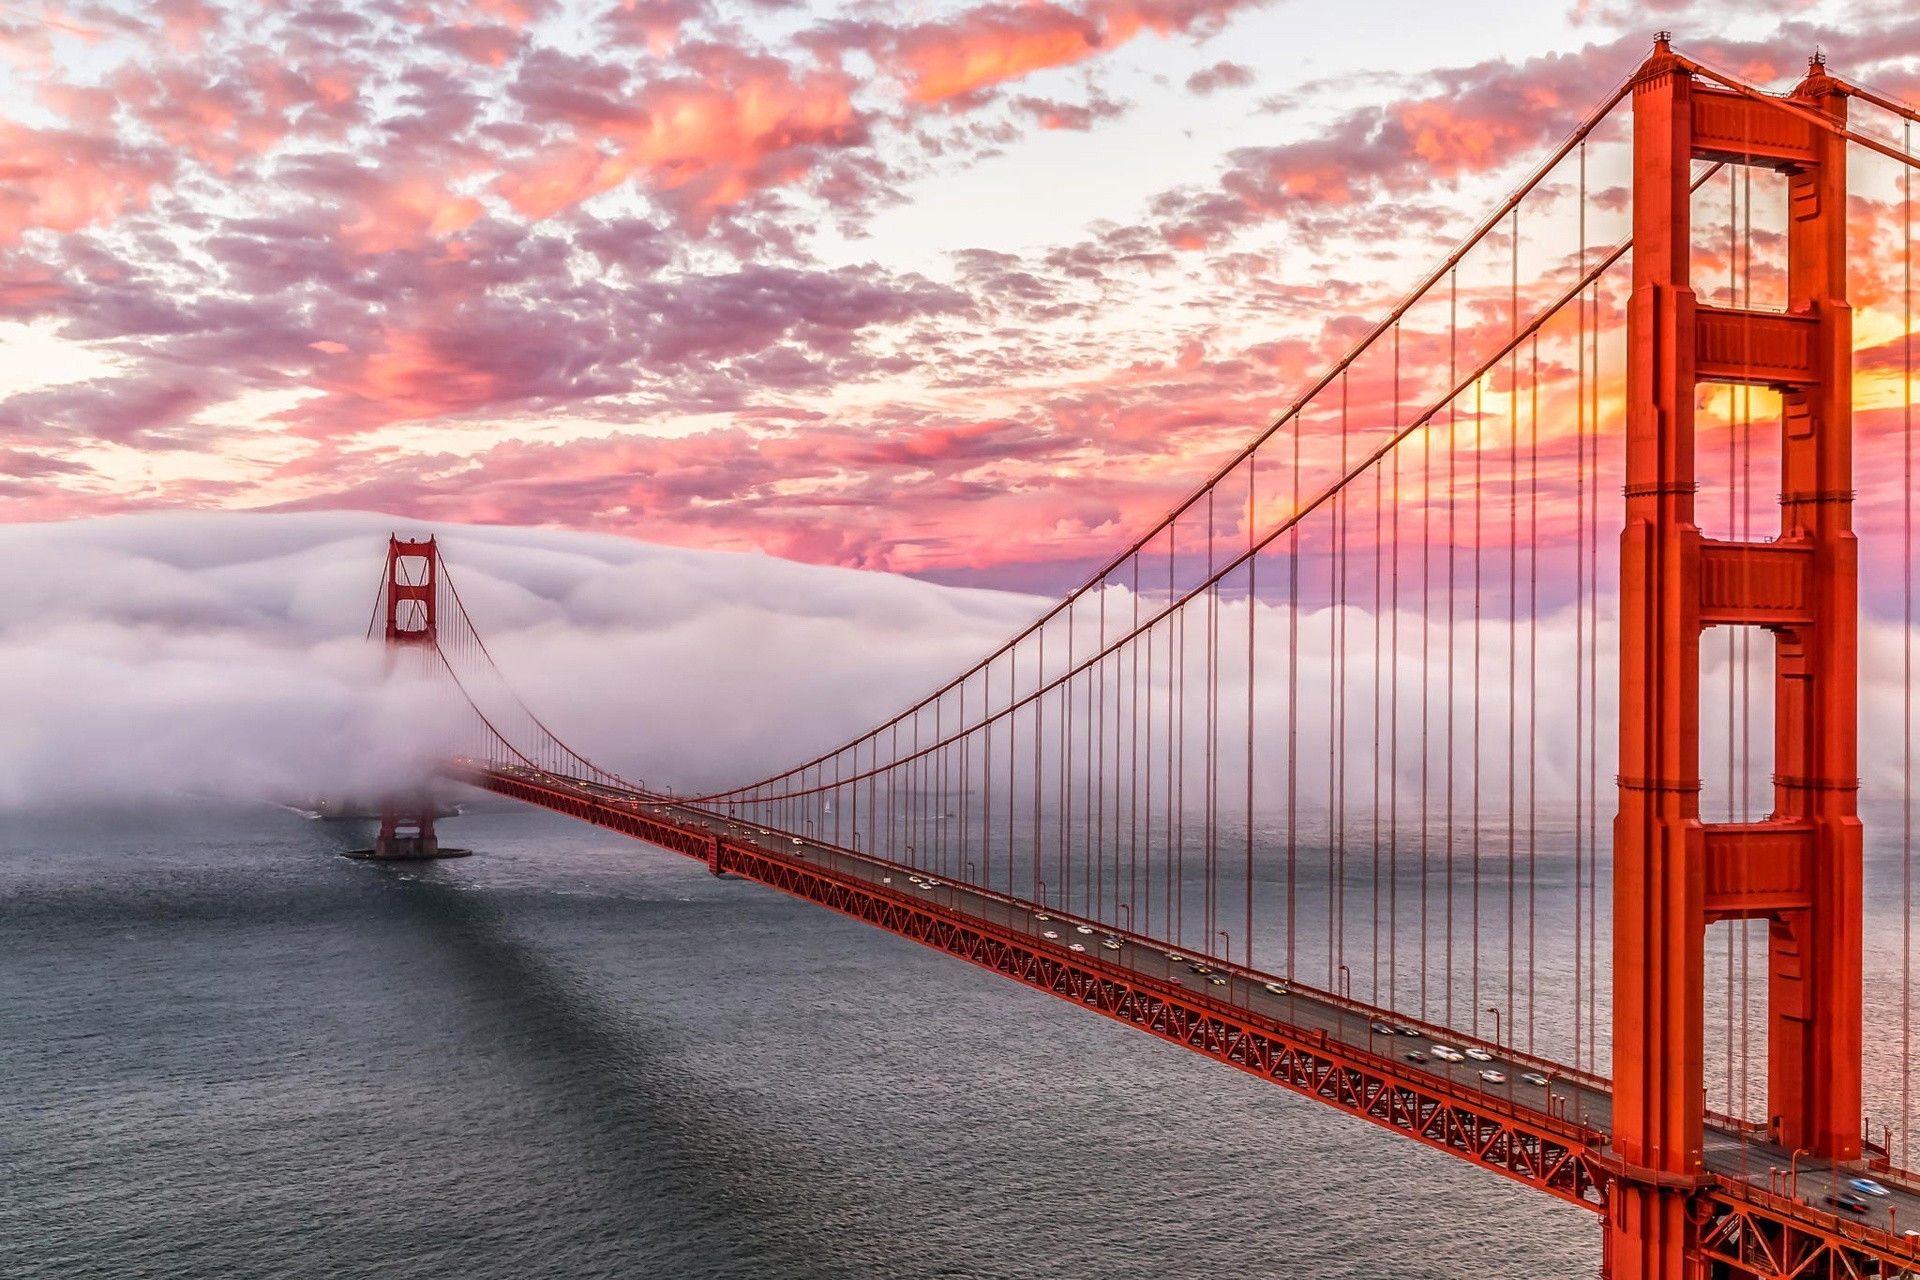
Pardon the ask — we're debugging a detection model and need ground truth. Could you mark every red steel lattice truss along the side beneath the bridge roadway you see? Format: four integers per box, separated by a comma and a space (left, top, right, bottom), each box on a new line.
447, 762, 1920, 1280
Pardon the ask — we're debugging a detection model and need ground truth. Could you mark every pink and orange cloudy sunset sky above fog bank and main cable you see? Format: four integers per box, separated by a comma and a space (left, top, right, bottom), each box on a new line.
0, 0, 1920, 589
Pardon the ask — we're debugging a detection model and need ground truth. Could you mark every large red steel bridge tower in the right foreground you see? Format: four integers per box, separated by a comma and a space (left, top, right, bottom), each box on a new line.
1607, 38, 1862, 1280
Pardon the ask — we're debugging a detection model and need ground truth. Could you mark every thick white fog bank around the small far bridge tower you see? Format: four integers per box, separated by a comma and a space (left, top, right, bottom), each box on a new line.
0, 512, 1037, 808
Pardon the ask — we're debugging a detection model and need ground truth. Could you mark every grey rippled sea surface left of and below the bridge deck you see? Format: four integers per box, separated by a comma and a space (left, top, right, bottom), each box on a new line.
0, 802, 1681, 1280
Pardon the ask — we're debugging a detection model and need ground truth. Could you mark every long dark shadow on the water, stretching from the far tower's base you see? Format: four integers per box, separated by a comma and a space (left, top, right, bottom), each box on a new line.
372, 867, 925, 1278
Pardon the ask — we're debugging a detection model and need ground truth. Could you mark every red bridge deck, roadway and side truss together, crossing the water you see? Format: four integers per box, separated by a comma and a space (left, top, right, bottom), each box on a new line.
447, 762, 1920, 1276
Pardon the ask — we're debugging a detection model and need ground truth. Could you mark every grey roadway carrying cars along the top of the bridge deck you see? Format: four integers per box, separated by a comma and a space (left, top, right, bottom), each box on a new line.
460, 766, 1920, 1276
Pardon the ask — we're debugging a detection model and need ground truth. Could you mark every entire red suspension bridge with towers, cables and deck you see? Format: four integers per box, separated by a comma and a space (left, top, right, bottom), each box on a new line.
360, 35, 1920, 1280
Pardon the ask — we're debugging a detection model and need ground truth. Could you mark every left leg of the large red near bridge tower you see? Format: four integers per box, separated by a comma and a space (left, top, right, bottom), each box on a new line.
1605, 42, 1705, 1280
